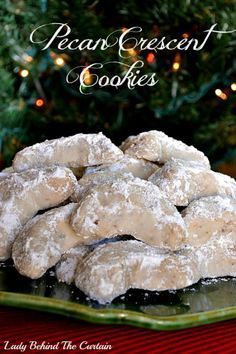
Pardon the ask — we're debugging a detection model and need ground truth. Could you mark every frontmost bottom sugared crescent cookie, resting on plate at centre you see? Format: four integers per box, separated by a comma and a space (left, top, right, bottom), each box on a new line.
75, 241, 200, 304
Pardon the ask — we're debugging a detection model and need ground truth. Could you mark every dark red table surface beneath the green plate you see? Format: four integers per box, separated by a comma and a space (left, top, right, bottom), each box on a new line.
0, 307, 236, 354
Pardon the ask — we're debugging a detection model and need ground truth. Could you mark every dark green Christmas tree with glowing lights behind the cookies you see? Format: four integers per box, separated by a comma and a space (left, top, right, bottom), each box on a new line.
0, 0, 236, 176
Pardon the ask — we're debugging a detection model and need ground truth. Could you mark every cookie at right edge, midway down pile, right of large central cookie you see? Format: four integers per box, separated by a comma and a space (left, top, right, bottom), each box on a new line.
182, 196, 236, 246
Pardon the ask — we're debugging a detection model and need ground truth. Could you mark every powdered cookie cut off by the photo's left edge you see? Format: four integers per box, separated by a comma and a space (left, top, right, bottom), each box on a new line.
0, 166, 77, 260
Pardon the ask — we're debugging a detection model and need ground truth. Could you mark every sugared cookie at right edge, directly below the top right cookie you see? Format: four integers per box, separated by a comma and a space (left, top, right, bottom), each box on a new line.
149, 159, 236, 206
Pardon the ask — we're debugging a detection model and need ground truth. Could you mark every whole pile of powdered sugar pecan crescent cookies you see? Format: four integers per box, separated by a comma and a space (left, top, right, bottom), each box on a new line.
0, 131, 236, 304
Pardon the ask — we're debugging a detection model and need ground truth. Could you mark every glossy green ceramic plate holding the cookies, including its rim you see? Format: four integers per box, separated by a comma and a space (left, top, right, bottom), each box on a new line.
0, 262, 236, 330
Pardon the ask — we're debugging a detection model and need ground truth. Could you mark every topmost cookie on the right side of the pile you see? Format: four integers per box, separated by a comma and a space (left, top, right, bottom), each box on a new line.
120, 130, 210, 168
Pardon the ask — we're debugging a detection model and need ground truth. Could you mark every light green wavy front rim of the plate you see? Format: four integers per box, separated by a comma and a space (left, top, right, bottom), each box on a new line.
0, 291, 236, 330
